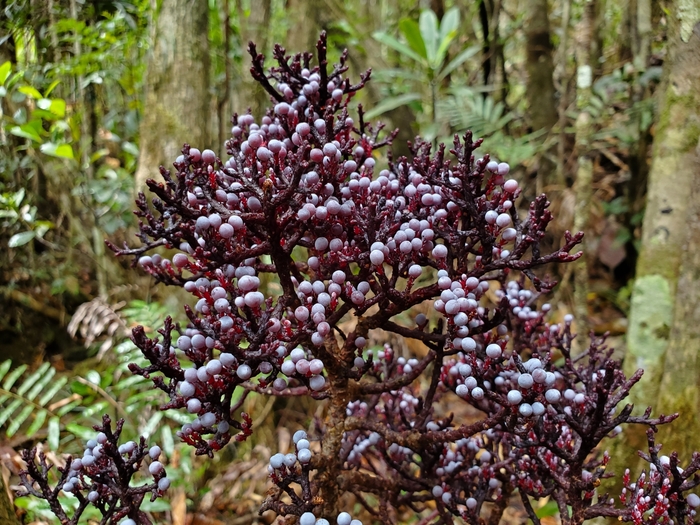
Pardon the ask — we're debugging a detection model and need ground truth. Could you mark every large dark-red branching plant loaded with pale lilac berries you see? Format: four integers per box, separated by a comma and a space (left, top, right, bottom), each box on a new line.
91, 35, 700, 525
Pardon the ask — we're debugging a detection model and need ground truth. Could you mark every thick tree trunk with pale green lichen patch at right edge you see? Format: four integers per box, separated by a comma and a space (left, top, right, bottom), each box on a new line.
611, 0, 700, 484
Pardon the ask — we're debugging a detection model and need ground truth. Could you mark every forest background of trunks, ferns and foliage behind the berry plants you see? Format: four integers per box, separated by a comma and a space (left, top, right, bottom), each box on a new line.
0, 0, 700, 525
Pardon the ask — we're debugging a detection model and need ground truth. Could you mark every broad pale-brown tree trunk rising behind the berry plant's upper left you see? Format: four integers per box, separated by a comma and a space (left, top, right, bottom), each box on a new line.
135, 0, 212, 191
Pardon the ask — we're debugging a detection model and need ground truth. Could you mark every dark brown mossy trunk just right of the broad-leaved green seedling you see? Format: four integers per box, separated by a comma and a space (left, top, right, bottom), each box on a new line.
524, 0, 558, 188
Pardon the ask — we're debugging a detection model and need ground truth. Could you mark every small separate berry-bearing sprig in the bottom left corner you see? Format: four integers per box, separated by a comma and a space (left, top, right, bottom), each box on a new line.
20, 416, 170, 525
